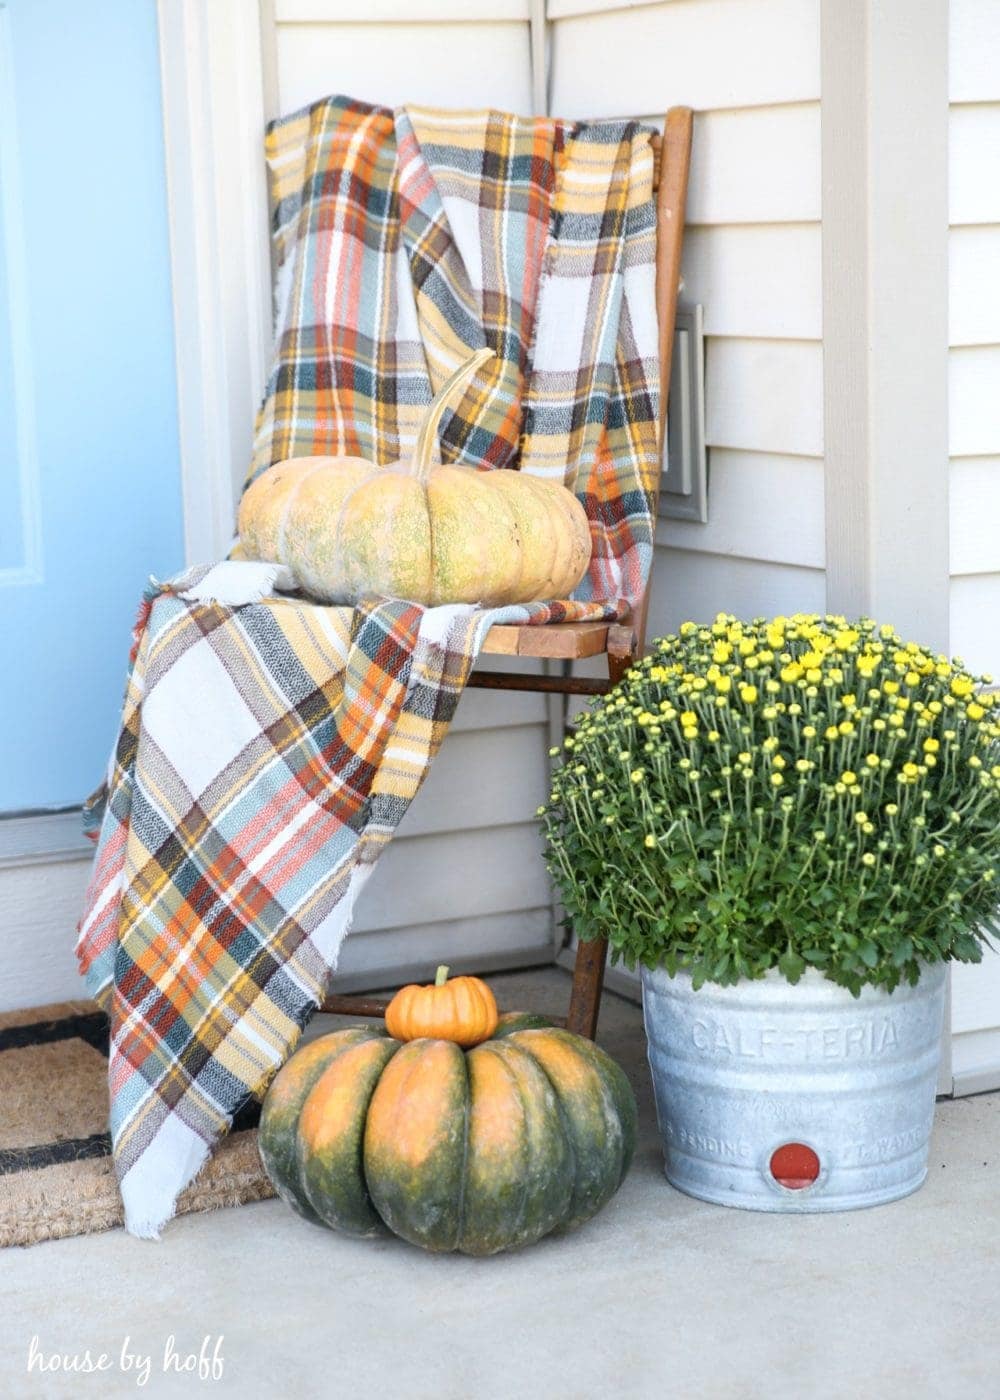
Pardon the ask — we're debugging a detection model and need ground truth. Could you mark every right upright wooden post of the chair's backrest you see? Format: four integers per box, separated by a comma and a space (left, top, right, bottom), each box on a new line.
630, 106, 693, 652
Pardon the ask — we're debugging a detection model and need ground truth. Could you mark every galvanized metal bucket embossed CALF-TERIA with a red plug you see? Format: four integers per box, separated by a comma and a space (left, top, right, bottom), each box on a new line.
643, 963, 945, 1211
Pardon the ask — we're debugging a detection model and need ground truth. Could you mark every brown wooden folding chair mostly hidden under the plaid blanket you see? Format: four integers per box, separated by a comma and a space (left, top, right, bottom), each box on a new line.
321, 106, 692, 1040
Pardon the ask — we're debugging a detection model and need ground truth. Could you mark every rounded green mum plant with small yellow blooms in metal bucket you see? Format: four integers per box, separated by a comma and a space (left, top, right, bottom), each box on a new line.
539, 613, 1000, 994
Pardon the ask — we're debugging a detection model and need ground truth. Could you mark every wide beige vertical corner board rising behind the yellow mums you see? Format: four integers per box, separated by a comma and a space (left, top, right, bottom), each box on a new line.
821, 0, 952, 1093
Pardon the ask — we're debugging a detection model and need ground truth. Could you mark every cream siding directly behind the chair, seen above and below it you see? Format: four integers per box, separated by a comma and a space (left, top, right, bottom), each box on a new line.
265, 0, 553, 990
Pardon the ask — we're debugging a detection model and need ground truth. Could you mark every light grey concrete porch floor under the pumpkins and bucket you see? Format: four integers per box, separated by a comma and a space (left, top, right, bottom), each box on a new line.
0, 969, 1000, 1400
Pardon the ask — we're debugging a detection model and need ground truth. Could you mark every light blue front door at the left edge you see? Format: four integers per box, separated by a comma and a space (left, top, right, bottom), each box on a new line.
0, 0, 183, 812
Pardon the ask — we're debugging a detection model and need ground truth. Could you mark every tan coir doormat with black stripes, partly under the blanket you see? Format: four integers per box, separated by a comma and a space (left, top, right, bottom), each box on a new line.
0, 1001, 275, 1247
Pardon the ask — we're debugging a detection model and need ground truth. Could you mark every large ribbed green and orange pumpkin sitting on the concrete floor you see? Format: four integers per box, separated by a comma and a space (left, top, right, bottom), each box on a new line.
259, 1015, 636, 1254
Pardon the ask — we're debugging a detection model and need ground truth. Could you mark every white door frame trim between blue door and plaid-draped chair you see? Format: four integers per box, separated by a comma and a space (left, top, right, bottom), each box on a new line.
157, 0, 272, 563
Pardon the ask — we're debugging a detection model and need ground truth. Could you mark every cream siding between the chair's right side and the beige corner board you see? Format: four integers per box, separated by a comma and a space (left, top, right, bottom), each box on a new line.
549, 0, 825, 636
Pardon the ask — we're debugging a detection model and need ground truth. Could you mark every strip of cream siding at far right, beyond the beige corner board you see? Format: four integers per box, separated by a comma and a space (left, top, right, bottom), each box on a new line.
948, 0, 1000, 1092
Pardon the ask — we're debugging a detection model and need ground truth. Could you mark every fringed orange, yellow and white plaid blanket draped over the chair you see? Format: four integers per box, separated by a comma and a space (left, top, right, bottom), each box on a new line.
77, 99, 657, 1236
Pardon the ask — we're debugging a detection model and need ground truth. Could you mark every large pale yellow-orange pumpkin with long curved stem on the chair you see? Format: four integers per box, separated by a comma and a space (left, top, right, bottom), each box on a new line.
239, 350, 591, 606
